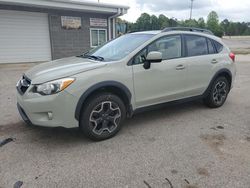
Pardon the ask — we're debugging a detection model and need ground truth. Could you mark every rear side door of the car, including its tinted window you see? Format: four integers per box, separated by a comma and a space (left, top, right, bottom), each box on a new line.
184, 34, 217, 96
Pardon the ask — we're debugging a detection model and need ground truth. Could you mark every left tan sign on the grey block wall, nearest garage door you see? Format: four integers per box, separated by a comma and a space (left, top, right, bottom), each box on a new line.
61, 16, 82, 29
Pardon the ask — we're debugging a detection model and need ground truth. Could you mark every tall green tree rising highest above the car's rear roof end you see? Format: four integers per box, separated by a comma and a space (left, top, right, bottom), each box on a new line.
207, 11, 223, 37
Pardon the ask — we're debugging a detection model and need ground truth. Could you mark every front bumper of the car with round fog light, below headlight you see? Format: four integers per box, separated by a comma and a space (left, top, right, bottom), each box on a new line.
17, 90, 78, 128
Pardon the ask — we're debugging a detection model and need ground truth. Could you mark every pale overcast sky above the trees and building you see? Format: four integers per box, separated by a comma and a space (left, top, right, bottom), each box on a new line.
86, 0, 250, 22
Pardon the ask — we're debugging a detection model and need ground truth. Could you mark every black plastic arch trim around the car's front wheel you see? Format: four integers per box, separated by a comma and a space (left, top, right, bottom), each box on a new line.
75, 81, 132, 121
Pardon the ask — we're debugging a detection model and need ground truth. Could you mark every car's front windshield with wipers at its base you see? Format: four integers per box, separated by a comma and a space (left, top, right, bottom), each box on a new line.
84, 34, 154, 61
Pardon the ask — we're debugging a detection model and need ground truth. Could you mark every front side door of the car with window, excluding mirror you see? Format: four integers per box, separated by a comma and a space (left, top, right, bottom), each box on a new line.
132, 35, 188, 107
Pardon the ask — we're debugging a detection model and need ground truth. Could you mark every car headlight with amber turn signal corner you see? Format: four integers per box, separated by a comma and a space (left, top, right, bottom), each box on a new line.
33, 78, 75, 95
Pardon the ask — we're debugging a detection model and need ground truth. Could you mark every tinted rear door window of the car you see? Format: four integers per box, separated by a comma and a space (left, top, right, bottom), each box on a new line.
185, 35, 208, 56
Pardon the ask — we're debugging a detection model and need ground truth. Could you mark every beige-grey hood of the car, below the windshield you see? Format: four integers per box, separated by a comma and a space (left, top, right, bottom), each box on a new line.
25, 57, 106, 84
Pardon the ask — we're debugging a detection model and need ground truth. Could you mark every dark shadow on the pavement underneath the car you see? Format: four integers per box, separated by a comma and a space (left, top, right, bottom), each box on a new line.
4, 101, 206, 147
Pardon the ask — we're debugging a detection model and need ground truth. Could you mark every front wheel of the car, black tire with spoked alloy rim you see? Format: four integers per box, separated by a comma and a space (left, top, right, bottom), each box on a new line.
80, 93, 126, 141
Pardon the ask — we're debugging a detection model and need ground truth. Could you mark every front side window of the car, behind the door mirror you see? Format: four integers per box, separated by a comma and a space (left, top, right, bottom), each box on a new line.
133, 35, 182, 64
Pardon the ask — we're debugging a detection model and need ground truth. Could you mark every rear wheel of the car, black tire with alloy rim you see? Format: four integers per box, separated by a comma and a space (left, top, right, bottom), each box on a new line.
204, 76, 230, 108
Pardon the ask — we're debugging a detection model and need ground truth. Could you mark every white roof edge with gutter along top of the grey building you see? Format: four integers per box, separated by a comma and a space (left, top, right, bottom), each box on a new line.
0, 0, 129, 16
